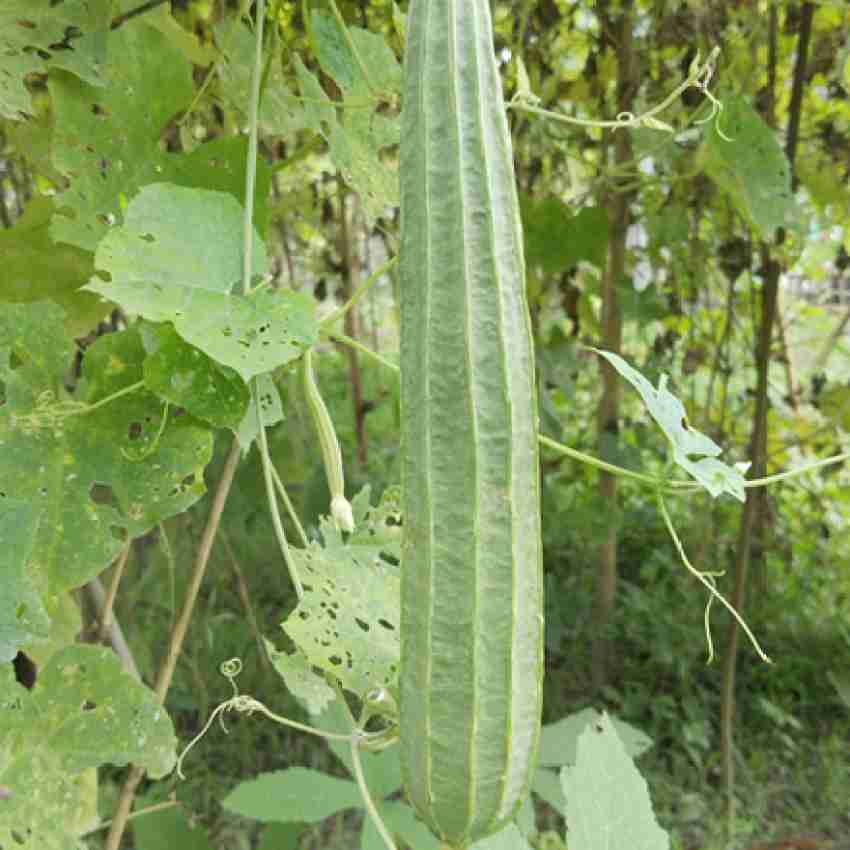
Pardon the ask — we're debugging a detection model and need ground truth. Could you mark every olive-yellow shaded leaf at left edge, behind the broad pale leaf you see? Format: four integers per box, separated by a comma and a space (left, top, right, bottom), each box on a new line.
0, 197, 94, 301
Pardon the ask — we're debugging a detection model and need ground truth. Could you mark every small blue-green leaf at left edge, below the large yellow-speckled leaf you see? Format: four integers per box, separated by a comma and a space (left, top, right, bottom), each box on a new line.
0, 494, 50, 662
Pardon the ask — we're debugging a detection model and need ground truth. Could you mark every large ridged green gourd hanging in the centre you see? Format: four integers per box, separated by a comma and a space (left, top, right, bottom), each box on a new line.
400, 0, 543, 848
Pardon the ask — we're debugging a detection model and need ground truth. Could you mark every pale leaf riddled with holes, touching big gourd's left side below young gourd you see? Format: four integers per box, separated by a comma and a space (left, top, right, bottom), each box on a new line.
276, 486, 400, 696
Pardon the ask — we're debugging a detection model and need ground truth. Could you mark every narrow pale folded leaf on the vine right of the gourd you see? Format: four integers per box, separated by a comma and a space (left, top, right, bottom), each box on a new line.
591, 348, 746, 502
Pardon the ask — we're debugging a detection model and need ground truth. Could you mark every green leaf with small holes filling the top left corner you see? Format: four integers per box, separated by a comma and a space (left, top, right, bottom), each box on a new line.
0, 0, 111, 121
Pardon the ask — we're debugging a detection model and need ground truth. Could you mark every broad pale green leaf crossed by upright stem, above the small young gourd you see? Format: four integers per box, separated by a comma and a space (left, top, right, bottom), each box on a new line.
86, 183, 318, 382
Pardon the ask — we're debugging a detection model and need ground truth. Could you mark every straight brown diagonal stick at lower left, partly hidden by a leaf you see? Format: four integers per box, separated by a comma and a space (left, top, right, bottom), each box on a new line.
104, 437, 241, 850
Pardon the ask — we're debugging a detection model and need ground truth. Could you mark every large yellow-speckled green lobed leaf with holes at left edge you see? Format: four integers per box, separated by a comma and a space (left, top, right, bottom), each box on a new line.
0, 302, 212, 594
